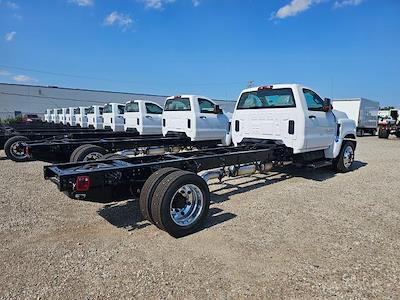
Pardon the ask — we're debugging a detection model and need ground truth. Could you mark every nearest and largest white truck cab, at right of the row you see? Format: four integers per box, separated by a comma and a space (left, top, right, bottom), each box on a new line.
232, 84, 356, 158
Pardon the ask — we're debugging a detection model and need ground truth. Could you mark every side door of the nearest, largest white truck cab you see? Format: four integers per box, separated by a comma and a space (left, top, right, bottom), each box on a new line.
303, 89, 336, 150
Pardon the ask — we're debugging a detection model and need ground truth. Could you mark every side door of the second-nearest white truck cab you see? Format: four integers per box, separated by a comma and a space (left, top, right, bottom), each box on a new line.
196, 98, 228, 140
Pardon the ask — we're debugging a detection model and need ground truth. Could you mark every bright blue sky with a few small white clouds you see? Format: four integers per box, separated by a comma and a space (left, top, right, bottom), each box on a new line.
0, 0, 400, 105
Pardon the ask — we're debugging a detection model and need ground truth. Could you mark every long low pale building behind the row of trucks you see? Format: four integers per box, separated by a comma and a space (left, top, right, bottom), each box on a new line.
0, 83, 235, 120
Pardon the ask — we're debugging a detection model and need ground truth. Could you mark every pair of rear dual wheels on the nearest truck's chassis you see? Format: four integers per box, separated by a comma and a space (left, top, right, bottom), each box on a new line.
139, 168, 210, 237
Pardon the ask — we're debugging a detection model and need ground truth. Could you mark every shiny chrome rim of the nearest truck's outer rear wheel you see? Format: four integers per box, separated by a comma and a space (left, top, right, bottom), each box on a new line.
170, 184, 204, 226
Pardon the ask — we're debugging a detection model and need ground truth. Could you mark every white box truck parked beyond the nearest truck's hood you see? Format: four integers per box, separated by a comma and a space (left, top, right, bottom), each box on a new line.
333, 98, 379, 136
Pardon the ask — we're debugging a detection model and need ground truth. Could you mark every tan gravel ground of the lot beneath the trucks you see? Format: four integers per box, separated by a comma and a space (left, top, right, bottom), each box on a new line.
0, 137, 400, 299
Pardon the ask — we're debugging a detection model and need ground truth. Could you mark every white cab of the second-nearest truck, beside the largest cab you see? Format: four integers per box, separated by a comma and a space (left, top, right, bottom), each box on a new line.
162, 95, 231, 145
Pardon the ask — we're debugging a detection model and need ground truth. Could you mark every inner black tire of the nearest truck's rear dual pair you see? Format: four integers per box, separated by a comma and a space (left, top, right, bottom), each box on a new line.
139, 167, 180, 225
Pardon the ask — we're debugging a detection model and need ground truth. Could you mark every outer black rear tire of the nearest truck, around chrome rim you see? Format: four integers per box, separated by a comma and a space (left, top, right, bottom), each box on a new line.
151, 171, 210, 238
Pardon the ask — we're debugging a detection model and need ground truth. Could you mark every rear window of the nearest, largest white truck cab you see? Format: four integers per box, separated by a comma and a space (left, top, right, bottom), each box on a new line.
237, 89, 296, 109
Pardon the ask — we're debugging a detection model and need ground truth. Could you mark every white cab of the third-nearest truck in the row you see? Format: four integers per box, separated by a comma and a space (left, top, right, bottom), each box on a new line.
124, 100, 163, 135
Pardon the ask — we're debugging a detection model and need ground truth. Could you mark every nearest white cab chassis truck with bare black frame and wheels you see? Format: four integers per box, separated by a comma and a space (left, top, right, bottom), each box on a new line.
44, 84, 356, 237
